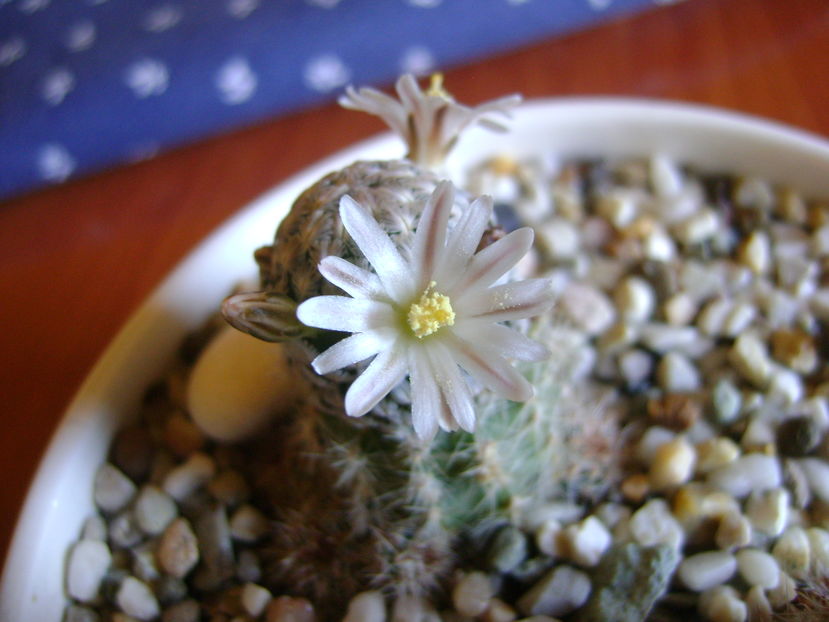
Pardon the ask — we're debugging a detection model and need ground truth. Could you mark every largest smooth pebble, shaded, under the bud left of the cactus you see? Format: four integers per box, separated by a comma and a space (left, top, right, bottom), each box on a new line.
187, 328, 302, 442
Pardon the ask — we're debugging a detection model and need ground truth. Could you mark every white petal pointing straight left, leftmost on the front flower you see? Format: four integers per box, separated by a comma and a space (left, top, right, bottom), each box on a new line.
296, 296, 395, 333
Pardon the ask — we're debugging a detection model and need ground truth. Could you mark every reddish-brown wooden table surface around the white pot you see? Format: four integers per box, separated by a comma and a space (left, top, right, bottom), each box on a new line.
0, 0, 829, 572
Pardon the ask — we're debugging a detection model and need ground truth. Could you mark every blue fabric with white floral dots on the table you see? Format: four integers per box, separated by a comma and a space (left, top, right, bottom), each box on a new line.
0, 0, 660, 198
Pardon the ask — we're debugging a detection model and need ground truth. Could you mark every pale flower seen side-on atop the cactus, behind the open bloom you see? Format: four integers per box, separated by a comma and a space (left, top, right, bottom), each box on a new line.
339, 74, 521, 168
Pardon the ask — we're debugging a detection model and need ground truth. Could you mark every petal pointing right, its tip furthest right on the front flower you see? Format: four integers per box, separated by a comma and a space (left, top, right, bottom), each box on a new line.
462, 279, 553, 322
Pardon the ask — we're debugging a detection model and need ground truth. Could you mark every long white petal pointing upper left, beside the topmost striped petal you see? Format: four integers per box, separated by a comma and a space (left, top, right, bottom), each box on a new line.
340, 195, 414, 302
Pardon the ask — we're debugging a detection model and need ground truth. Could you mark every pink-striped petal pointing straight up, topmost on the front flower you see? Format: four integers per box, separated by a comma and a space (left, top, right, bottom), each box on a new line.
412, 181, 455, 290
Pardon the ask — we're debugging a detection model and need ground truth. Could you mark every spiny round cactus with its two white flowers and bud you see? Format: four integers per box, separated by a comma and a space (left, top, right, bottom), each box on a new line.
218, 76, 600, 612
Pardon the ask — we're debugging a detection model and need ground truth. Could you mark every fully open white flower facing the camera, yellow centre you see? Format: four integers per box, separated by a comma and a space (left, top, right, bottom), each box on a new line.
297, 182, 552, 439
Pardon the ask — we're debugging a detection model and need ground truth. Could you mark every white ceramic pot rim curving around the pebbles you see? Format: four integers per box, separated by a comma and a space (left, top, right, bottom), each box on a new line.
0, 99, 829, 622
